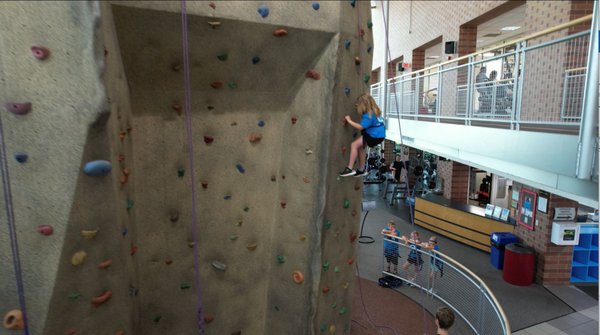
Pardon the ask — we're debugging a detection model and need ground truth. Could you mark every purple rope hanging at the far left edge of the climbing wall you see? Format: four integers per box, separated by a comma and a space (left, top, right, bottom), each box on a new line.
0, 112, 29, 335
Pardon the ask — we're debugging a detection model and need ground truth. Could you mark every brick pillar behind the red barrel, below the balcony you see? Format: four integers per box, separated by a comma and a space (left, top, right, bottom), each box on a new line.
514, 183, 578, 285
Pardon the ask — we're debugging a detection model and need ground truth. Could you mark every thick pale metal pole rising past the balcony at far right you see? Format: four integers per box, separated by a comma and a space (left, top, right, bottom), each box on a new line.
575, 2, 598, 179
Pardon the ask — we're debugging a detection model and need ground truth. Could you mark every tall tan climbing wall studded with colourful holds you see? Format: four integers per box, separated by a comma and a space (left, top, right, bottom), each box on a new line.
0, 1, 372, 334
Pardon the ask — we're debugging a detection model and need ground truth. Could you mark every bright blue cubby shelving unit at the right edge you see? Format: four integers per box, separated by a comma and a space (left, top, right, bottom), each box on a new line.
571, 224, 598, 283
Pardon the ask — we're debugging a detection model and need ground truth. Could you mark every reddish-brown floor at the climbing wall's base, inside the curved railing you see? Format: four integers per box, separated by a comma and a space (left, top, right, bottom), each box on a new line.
350, 278, 436, 335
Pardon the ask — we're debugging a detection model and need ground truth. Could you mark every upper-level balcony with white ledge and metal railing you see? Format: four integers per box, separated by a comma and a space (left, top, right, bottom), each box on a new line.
371, 15, 598, 208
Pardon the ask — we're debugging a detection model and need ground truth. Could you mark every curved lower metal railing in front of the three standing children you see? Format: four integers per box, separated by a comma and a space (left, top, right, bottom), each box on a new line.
382, 235, 511, 335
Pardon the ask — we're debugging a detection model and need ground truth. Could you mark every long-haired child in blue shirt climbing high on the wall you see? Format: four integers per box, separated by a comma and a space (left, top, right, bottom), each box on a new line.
340, 93, 385, 177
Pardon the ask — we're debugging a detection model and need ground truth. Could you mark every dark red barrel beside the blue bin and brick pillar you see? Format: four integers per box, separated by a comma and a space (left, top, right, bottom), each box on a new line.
502, 243, 535, 286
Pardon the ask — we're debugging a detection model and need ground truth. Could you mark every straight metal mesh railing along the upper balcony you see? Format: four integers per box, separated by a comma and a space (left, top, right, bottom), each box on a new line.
371, 15, 591, 131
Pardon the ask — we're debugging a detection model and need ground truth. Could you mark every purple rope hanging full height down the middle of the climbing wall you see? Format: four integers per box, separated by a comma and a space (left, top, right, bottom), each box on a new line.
181, 0, 205, 335
